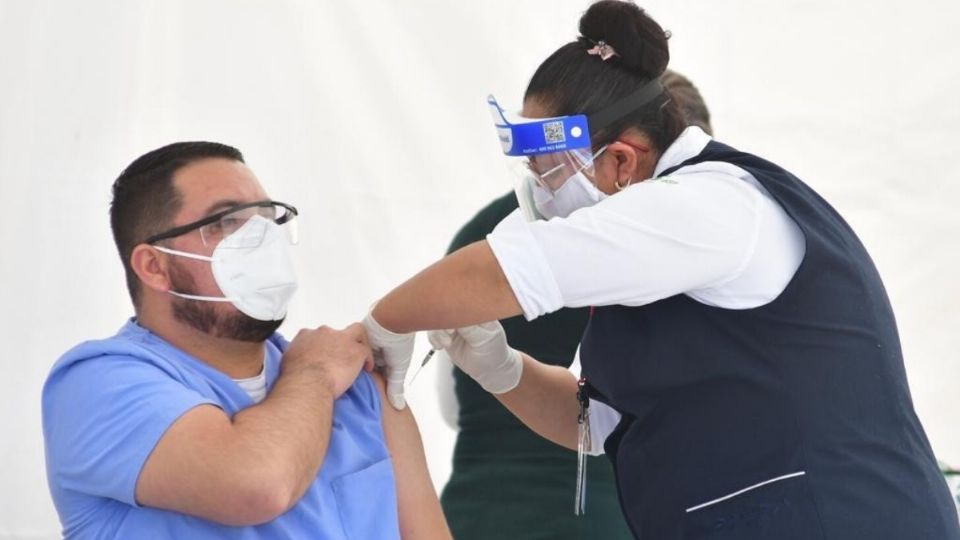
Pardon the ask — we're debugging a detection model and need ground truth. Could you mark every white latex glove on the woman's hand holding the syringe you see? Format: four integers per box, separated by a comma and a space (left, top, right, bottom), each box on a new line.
427, 321, 523, 394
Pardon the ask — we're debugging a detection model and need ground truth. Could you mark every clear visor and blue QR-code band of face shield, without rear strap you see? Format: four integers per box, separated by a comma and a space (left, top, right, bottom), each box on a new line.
487, 96, 605, 221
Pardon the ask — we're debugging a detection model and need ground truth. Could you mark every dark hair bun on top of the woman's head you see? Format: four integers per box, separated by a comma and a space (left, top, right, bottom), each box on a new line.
579, 0, 670, 80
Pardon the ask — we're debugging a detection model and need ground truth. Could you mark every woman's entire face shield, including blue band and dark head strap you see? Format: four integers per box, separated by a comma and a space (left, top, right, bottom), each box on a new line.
487, 79, 663, 221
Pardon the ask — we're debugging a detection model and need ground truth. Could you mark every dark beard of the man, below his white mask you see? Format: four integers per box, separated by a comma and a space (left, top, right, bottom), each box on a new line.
170, 263, 283, 343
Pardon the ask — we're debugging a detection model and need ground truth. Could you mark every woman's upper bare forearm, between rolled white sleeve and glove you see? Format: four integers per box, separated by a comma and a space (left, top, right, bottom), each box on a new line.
373, 240, 523, 333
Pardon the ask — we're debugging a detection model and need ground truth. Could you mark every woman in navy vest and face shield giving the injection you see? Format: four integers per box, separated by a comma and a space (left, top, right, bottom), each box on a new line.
365, 0, 960, 540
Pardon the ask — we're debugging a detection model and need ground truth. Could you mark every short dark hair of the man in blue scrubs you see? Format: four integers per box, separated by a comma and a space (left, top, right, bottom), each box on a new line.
110, 141, 244, 306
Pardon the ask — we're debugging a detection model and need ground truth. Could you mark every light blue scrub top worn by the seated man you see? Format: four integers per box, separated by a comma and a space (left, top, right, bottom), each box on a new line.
43, 320, 399, 539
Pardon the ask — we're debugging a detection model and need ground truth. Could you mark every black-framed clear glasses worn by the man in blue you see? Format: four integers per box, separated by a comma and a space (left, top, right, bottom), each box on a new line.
144, 201, 297, 247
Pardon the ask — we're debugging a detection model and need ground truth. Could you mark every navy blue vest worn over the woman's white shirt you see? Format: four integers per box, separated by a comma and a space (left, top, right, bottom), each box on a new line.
581, 142, 960, 540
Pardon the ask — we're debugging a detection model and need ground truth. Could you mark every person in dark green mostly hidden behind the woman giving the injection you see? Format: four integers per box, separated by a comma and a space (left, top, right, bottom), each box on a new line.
440, 70, 713, 540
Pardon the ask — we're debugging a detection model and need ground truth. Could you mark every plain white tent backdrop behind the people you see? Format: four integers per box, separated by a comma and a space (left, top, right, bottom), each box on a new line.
0, 0, 960, 539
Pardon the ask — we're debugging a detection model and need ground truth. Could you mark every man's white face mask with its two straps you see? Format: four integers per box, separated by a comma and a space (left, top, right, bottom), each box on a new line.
154, 216, 297, 321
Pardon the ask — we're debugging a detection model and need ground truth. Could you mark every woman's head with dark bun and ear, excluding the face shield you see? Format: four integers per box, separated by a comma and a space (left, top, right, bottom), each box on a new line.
521, 0, 687, 195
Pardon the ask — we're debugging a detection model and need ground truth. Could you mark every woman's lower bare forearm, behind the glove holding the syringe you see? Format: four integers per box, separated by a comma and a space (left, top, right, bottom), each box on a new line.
494, 354, 579, 450
